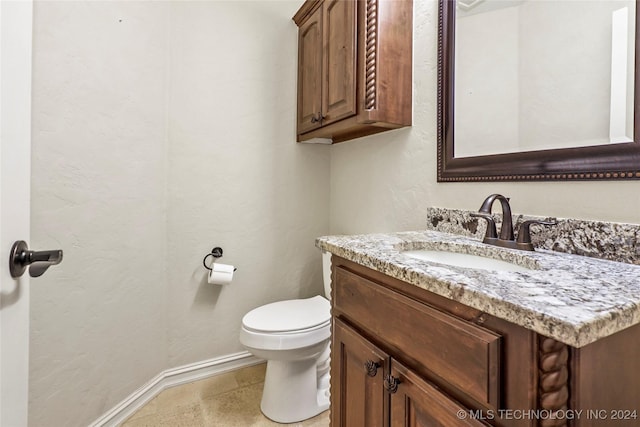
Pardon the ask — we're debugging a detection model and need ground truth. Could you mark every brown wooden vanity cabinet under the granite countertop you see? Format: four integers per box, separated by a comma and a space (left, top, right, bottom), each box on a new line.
330, 255, 640, 427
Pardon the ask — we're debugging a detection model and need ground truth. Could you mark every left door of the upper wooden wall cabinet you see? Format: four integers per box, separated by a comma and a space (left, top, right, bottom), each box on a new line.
298, 7, 323, 134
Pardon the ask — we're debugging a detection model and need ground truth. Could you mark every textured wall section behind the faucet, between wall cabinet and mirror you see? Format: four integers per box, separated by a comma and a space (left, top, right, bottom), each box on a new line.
330, 0, 640, 234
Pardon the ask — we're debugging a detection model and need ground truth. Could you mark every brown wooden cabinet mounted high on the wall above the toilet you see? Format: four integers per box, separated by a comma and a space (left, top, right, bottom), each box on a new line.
293, 0, 413, 142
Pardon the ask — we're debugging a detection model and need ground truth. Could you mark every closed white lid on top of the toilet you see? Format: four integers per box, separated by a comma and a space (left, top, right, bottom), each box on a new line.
242, 295, 331, 332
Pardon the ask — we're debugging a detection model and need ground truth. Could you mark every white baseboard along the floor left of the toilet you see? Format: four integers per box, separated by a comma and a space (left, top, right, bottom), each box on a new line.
89, 351, 263, 427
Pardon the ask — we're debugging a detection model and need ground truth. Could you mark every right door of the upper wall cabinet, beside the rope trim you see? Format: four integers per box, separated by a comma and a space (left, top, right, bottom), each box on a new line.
322, 0, 358, 125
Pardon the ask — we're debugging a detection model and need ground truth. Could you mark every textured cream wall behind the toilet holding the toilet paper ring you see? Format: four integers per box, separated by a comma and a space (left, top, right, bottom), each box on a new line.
167, 1, 329, 366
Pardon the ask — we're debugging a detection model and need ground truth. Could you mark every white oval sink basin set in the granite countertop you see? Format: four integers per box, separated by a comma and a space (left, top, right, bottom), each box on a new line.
402, 249, 532, 273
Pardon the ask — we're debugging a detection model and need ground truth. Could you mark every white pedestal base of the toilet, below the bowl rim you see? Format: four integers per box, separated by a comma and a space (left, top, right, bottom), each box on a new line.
260, 345, 329, 423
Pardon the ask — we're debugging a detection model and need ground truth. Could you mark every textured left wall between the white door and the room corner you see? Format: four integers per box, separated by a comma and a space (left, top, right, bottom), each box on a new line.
29, 1, 168, 427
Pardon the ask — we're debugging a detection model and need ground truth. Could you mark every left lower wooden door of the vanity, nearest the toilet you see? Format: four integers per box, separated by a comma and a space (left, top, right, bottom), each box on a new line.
331, 319, 389, 427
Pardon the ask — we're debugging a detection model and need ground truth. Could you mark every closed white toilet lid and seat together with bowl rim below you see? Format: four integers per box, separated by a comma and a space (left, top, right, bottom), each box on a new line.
240, 295, 331, 350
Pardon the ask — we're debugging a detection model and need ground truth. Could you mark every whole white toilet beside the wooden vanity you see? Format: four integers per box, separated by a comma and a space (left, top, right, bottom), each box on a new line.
240, 252, 331, 423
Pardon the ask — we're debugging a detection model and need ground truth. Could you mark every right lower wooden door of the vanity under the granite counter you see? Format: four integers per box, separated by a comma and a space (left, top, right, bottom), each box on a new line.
385, 360, 488, 427
